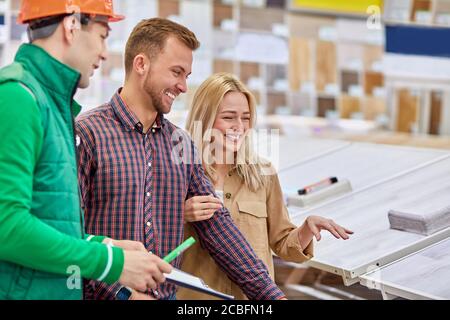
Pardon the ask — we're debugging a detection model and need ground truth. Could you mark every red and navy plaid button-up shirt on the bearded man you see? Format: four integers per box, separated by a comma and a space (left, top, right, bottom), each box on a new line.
76, 93, 284, 299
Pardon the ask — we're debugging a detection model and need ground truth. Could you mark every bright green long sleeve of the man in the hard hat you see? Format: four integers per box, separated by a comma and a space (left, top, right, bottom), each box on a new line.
0, 82, 124, 283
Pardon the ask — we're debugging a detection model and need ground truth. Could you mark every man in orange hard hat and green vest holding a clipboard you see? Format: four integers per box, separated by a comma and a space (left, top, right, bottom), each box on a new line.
0, 0, 171, 300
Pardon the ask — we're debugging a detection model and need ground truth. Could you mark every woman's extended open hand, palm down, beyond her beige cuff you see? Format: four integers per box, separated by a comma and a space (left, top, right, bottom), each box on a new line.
299, 216, 353, 248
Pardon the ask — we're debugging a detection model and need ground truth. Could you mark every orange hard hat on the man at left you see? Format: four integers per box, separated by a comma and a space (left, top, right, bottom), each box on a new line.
17, 0, 125, 23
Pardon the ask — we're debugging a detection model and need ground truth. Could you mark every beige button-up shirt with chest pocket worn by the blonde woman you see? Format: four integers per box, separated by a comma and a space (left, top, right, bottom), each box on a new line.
177, 171, 313, 299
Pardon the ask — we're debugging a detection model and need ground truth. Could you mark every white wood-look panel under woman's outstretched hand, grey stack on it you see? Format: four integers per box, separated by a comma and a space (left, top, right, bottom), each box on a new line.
292, 157, 450, 277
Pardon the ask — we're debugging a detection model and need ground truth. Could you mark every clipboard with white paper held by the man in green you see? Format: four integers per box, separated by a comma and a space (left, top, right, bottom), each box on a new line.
164, 268, 234, 300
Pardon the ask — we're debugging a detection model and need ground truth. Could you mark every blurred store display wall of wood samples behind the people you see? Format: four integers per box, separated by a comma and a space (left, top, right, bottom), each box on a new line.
0, 0, 450, 139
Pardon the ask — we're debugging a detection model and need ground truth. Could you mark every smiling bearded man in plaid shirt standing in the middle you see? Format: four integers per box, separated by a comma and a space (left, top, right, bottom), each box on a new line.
77, 18, 284, 299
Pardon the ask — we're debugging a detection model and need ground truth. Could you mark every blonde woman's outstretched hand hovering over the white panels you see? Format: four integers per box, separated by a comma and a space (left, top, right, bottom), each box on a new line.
299, 216, 353, 241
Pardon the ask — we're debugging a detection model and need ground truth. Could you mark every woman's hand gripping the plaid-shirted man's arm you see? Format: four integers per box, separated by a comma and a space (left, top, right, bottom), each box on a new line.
184, 196, 223, 222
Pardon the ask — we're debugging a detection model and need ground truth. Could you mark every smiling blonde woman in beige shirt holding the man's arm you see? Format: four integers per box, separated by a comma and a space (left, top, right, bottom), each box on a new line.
177, 73, 352, 299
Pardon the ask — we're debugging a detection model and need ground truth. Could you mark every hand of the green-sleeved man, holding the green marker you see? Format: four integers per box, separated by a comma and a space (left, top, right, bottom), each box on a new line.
119, 250, 172, 292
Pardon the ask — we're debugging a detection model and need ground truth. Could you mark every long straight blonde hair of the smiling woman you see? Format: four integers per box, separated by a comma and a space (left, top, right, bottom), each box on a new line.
186, 73, 270, 191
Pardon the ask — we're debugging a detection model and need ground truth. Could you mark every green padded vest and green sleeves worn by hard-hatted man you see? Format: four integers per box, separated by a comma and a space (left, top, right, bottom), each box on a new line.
0, 44, 124, 300
